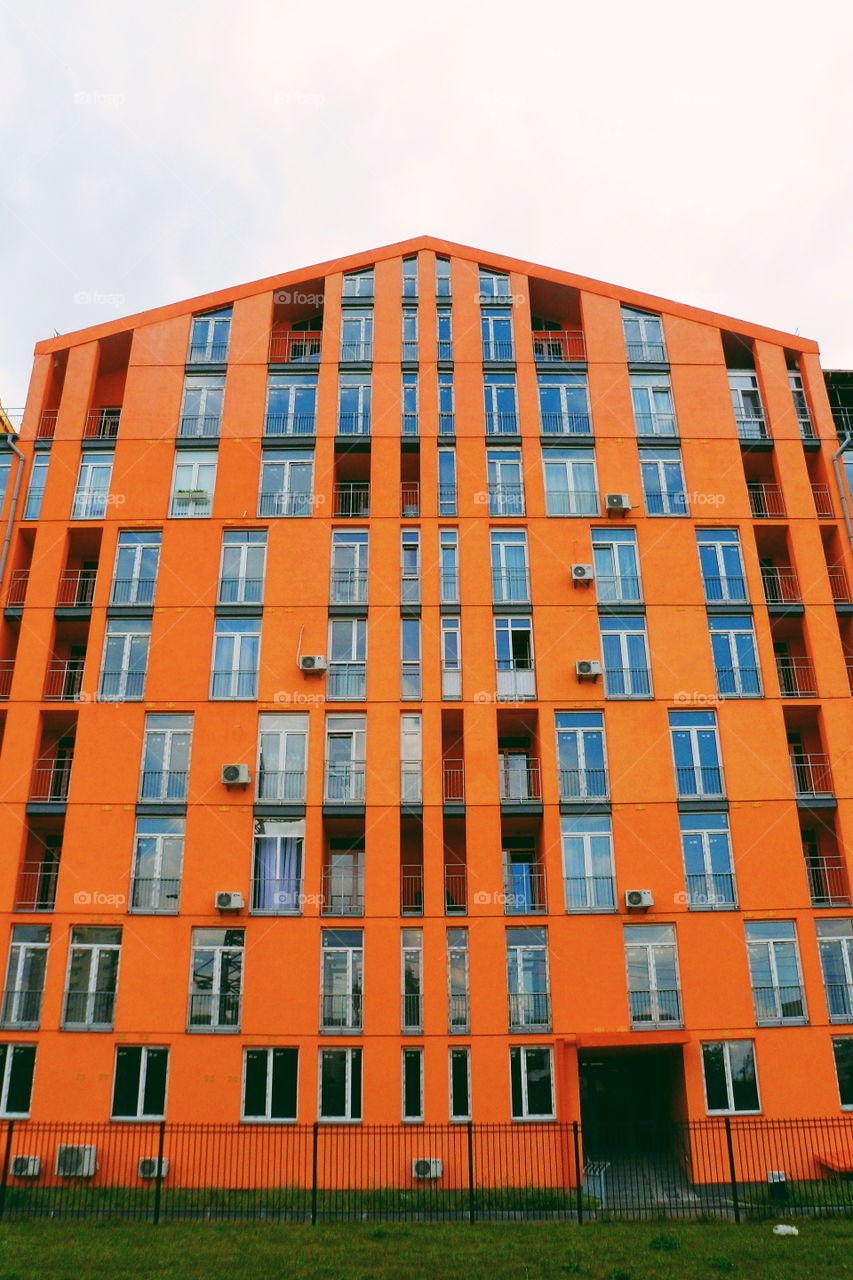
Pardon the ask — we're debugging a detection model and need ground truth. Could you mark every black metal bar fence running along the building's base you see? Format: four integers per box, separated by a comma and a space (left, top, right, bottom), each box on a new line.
0, 1115, 853, 1224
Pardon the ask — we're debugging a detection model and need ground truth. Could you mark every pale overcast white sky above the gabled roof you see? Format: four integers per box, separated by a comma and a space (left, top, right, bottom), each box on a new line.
0, 0, 853, 407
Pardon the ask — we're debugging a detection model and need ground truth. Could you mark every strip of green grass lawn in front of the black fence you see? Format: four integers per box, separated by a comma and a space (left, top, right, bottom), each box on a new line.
0, 1219, 853, 1280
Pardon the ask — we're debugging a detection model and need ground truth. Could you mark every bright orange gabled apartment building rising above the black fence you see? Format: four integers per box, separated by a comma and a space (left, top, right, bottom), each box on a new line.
0, 237, 853, 1146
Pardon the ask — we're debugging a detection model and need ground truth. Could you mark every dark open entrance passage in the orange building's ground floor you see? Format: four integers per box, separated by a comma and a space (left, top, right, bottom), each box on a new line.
578, 1046, 684, 1156
